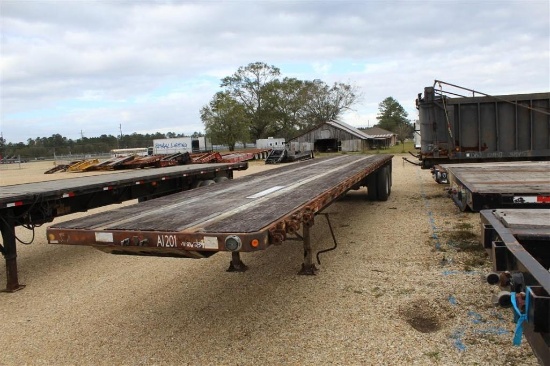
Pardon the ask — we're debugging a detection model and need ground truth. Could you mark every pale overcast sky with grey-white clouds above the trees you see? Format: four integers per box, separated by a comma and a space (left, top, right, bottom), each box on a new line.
0, 0, 550, 143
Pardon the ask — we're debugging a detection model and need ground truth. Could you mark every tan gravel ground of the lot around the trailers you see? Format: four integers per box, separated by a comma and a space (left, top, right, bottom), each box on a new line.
0, 156, 538, 365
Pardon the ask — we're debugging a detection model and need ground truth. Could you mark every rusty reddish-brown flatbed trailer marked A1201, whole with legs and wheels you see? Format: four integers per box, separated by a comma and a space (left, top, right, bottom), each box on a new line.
47, 155, 392, 274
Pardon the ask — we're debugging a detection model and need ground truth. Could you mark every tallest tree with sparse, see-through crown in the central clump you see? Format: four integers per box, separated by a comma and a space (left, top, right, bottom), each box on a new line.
221, 62, 281, 139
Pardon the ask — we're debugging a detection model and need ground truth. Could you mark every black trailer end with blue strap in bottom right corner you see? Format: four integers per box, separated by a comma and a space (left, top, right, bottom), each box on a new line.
480, 209, 550, 365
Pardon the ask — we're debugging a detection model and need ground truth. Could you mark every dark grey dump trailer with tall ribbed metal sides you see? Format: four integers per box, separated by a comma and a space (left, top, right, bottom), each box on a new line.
416, 80, 550, 183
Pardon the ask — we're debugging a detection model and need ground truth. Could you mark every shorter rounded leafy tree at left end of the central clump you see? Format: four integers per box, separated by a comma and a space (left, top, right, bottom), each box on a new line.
201, 92, 249, 151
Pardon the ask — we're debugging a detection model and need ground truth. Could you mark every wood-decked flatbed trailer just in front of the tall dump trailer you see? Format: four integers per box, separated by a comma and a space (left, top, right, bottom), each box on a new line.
442, 161, 550, 212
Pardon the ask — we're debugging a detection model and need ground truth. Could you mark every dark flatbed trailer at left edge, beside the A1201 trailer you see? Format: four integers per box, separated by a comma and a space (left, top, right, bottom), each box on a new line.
0, 162, 248, 292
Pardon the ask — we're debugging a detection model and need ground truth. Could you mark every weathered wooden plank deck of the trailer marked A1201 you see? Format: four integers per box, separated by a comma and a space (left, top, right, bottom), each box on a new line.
52, 155, 388, 233
